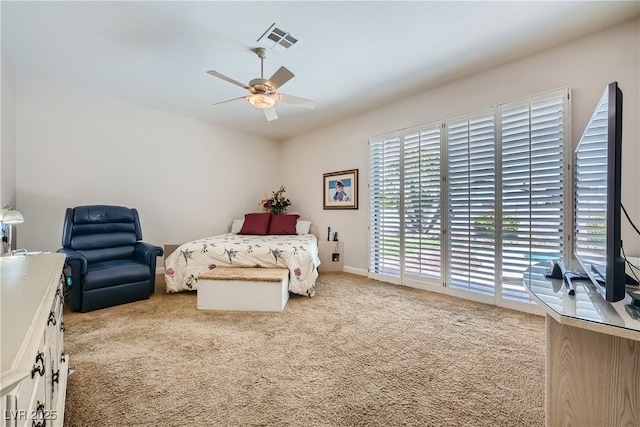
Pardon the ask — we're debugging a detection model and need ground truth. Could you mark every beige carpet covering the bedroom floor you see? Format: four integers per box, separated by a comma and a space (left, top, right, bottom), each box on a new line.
65, 273, 544, 427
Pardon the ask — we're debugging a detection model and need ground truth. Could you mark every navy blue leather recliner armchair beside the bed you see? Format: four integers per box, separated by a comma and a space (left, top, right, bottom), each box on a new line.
57, 205, 164, 312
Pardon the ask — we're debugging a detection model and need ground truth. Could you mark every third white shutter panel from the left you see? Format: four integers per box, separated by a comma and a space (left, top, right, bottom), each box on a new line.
447, 110, 495, 295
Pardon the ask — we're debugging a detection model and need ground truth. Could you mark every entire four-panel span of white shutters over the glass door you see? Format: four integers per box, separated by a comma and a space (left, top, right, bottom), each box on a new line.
369, 89, 570, 309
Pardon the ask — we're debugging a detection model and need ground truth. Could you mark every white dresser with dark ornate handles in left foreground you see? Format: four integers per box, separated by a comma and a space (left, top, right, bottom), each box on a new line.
0, 254, 69, 427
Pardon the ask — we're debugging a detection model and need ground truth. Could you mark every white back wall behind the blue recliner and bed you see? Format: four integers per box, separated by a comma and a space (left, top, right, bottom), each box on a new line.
14, 75, 280, 251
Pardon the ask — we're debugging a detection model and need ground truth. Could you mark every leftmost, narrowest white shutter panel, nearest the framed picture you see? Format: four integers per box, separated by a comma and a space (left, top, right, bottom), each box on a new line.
369, 135, 402, 278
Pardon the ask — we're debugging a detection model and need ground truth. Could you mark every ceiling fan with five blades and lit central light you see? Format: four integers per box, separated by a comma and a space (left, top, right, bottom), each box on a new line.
207, 47, 316, 121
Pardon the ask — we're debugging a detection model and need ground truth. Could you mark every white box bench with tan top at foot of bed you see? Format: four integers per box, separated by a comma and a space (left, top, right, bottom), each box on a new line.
197, 267, 289, 311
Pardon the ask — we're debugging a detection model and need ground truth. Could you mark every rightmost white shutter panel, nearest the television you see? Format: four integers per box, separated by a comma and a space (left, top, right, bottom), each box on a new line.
499, 90, 568, 301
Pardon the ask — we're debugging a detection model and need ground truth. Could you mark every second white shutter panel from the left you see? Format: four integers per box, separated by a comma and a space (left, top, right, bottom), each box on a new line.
402, 123, 442, 279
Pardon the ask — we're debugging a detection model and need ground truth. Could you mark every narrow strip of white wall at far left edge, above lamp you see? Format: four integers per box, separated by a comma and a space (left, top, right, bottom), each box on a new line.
0, 47, 17, 209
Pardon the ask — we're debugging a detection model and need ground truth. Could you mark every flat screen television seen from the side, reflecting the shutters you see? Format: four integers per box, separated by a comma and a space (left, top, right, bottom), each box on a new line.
574, 82, 626, 302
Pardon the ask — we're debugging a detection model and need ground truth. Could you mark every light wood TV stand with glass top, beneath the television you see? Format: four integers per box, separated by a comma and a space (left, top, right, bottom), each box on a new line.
524, 262, 640, 427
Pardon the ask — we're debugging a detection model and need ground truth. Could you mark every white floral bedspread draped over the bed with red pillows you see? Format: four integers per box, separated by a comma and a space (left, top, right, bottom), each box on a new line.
164, 233, 320, 296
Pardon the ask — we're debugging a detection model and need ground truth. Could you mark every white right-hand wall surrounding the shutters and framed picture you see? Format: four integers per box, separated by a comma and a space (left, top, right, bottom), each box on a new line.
282, 19, 640, 272
